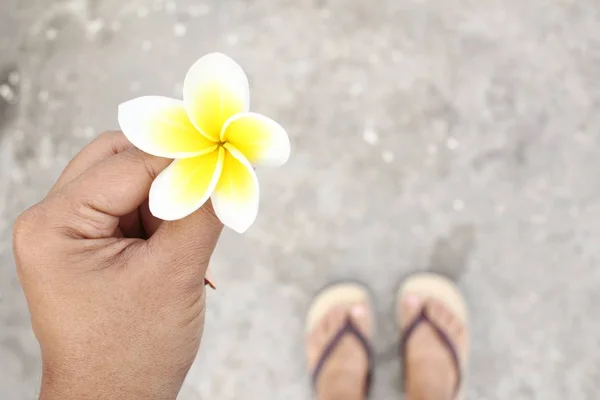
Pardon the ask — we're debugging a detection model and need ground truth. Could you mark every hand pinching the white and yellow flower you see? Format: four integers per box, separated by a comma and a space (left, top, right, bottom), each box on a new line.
14, 132, 222, 400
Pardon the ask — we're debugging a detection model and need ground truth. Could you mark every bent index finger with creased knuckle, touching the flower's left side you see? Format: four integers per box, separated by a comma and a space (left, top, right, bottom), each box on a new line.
46, 149, 171, 238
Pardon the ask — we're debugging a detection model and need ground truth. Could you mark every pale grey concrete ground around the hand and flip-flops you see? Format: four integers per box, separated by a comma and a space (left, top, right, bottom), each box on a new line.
0, 0, 600, 400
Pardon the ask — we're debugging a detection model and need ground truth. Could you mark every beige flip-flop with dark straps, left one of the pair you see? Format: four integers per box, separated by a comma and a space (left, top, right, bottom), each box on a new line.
306, 282, 374, 397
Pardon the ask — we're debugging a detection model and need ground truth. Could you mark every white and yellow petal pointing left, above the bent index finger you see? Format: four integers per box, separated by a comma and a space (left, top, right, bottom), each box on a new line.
119, 96, 217, 158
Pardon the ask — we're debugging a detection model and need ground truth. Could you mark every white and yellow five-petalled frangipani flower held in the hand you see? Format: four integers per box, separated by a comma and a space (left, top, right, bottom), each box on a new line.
119, 53, 290, 233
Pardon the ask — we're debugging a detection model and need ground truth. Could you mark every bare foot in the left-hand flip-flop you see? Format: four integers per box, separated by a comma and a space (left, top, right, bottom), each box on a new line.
306, 304, 372, 400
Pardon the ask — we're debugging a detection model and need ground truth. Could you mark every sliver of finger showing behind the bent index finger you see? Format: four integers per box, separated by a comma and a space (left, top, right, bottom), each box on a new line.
50, 131, 133, 193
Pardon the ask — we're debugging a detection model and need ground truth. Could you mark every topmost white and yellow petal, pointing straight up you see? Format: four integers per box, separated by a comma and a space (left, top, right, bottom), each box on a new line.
183, 53, 250, 141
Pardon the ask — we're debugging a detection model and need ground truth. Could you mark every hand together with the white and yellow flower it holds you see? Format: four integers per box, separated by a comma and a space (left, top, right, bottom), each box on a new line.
14, 54, 289, 400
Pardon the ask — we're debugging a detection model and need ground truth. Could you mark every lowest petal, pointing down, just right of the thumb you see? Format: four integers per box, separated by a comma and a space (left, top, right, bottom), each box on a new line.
211, 143, 259, 233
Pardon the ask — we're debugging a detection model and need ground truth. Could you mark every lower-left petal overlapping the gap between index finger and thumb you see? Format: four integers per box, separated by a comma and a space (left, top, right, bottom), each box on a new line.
150, 147, 225, 221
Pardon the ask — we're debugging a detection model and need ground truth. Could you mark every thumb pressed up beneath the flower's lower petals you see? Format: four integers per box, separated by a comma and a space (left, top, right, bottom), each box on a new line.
146, 201, 223, 283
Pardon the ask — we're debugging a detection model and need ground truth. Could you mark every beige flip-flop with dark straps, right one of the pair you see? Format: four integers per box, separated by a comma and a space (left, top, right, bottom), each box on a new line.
396, 273, 469, 400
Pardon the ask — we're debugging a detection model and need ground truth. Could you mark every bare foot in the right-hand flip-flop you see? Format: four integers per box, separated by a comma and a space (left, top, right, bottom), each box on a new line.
400, 294, 467, 400
